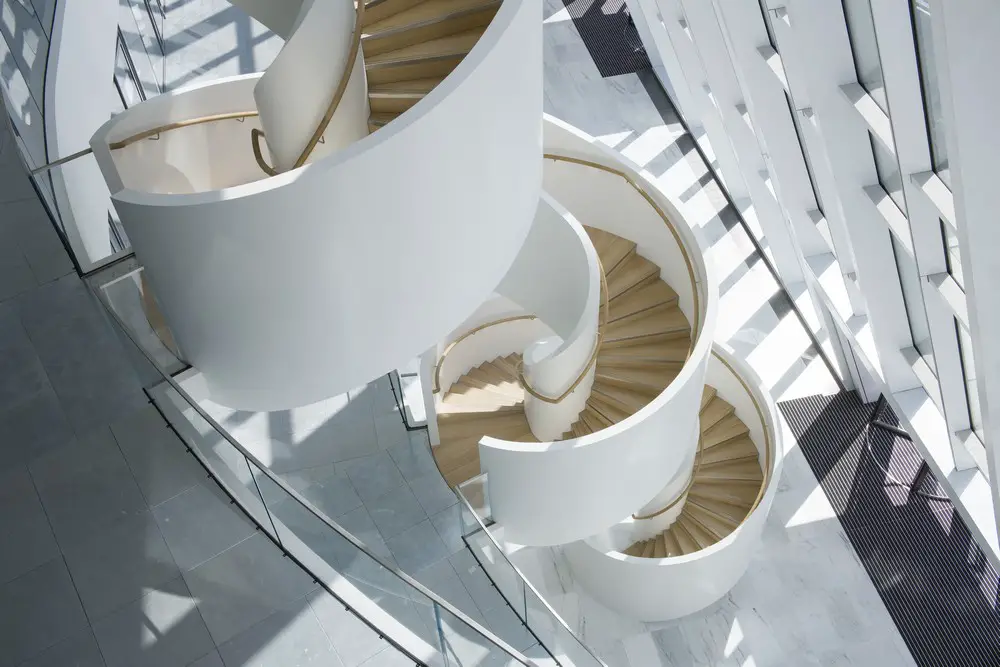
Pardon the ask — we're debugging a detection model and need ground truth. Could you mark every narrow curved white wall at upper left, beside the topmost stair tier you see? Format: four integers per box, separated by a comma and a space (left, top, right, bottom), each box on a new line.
45, 0, 119, 271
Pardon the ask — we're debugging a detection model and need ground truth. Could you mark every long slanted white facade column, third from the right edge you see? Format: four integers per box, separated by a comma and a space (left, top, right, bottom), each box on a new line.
789, 0, 916, 391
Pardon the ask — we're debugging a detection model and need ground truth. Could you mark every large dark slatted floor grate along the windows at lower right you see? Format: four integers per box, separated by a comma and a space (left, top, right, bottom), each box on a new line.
779, 392, 1000, 667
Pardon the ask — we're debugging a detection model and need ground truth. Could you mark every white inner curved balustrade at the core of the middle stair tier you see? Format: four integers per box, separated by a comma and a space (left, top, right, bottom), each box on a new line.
497, 192, 601, 440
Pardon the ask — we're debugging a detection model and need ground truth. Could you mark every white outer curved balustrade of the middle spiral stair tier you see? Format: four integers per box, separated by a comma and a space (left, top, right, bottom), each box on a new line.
479, 116, 718, 545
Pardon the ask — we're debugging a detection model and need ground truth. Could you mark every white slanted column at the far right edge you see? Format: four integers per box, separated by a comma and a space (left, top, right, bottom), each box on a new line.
932, 0, 1000, 544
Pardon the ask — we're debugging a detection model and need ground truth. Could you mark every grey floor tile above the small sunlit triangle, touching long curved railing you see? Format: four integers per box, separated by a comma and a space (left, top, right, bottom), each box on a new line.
153, 481, 256, 570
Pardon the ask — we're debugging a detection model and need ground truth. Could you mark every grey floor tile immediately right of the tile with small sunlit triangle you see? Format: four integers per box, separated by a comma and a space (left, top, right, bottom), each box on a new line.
184, 534, 316, 645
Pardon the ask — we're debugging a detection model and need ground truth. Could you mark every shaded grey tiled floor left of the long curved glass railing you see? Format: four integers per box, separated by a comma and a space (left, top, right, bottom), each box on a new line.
0, 115, 402, 667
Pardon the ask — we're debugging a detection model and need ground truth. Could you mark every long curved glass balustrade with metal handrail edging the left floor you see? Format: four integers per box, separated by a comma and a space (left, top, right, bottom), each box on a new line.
93, 268, 537, 667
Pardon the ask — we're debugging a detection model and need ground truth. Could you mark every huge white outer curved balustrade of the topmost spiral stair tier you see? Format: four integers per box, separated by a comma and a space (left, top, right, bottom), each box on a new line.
92, 0, 542, 410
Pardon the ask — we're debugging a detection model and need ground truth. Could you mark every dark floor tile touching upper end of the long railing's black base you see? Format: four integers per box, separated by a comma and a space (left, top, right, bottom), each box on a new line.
111, 404, 205, 507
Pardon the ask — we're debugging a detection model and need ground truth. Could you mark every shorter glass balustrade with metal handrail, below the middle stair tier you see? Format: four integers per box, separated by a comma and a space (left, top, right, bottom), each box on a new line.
455, 473, 607, 667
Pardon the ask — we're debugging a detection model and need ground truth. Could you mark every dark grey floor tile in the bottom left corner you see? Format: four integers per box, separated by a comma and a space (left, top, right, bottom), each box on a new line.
0, 557, 87, 664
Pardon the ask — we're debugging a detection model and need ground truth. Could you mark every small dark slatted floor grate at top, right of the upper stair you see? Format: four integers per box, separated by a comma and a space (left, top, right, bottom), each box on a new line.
563, 0, 651, 77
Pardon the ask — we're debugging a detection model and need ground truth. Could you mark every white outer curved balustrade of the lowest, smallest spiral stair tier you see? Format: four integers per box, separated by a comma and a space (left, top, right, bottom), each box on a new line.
564, 345, 783, 621
